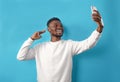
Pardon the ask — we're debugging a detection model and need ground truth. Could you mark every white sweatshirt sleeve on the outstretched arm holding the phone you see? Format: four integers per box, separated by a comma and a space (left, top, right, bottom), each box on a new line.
72, 30, 101, 55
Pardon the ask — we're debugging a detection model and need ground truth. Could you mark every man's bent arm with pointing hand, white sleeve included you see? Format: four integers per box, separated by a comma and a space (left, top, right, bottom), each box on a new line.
17, 30, 45, 60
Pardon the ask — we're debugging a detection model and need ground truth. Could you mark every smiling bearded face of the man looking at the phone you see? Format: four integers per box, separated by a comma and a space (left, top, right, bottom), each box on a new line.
48, 20, 64, 37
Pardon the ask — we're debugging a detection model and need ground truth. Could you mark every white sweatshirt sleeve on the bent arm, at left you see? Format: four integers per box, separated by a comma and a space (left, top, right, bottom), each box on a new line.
17, 38, 35, 60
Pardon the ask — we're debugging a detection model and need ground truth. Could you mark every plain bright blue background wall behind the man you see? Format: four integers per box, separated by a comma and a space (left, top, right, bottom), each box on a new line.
0, 0, 120, 82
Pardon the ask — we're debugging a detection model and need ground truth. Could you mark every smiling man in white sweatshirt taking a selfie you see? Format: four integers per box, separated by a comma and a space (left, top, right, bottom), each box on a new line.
17, 10, 103, 82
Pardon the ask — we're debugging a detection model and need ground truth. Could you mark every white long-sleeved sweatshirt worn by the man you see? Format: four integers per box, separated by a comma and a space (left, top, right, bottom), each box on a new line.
17, 30, 100, 82
